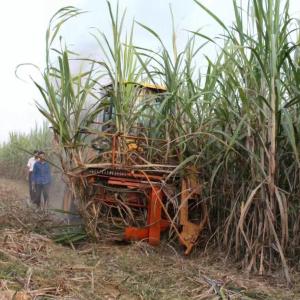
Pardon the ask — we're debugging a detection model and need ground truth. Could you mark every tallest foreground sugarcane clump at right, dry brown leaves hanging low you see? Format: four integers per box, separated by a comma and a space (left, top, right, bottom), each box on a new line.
192, 0, 299, 281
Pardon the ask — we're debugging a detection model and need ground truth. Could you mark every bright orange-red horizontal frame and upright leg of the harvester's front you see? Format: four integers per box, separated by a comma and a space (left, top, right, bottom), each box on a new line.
87, 169, 170, 246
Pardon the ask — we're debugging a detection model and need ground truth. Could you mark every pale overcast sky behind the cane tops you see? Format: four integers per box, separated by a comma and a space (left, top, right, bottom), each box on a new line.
0, 0, 300, 143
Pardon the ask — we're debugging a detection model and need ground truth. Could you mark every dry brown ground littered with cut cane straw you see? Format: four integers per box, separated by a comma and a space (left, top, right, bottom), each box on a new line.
0, 178, 300, 300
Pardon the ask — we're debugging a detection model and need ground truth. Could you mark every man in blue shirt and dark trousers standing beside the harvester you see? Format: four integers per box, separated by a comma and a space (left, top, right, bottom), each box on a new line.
32, 151, 51, 208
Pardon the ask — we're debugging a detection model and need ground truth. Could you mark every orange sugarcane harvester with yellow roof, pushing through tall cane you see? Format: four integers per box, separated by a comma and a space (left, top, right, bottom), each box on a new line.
68, 85, 208, 255
